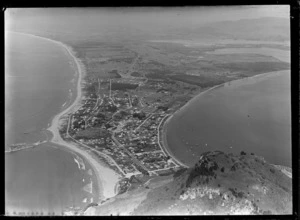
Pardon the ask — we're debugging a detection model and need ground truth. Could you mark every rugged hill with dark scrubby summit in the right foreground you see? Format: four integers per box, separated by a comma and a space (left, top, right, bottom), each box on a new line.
85, 151, 292, 215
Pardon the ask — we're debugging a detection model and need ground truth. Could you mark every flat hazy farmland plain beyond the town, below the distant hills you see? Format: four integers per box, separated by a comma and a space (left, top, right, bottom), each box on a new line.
63, 36, 290, 91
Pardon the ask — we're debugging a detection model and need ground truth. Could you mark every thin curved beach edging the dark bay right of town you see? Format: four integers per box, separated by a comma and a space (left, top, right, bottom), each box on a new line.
161, 70, 288, 167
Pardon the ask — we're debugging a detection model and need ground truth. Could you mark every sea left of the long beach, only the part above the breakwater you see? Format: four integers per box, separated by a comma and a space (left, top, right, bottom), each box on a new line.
5, 33, 76, 146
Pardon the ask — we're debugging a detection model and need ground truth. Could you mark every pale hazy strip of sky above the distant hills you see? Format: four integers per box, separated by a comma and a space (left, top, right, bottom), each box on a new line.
5, 5, 289, 24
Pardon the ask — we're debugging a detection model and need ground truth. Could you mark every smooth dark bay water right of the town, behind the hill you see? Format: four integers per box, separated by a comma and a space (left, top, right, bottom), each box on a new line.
166, 70, 292, 167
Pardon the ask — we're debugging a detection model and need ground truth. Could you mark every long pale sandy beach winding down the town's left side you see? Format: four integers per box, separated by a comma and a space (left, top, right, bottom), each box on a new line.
11, 31, 120, 201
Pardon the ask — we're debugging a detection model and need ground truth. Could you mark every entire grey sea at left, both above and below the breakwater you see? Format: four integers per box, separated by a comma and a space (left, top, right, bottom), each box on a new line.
5, 32, 98, 215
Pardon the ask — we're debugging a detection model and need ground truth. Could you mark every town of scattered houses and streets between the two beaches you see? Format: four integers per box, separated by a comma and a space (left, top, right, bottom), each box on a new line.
60, 74, 199, 194
